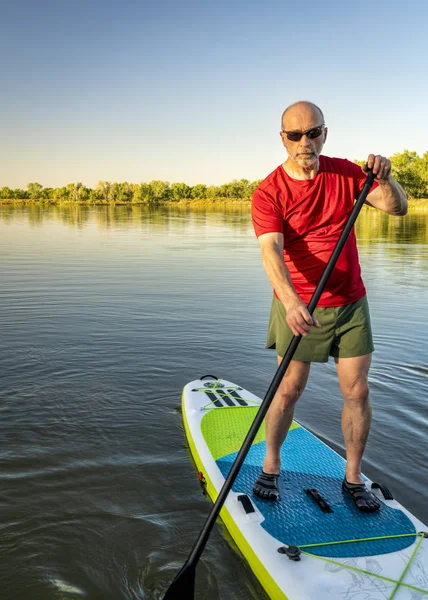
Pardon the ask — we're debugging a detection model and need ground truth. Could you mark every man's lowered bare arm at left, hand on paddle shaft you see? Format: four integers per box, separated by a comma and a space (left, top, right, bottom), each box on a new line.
258, 232, 319, 336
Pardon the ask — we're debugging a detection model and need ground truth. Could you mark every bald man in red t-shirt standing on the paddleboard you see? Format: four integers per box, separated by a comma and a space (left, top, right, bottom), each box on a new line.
252, 102, 407, 512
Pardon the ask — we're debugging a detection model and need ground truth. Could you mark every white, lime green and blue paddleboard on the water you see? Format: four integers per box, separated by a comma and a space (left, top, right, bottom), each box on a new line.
182, 376, 428, 600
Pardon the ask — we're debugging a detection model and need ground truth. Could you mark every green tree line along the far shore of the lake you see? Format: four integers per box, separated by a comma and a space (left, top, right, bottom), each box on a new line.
0, 150, 428, 205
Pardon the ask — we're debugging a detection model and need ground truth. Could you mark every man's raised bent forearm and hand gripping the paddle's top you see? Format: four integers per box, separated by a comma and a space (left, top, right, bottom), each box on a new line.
361, 154, 407, 216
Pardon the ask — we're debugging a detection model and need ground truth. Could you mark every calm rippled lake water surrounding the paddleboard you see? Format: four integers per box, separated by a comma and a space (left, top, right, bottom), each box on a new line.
0, 206, 428, 600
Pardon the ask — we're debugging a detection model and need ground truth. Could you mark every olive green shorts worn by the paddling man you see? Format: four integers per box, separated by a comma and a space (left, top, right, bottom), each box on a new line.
266, 296, 374, 362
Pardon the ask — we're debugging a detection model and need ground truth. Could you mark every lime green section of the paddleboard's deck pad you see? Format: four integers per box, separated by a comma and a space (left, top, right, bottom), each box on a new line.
201, 406, 300, 460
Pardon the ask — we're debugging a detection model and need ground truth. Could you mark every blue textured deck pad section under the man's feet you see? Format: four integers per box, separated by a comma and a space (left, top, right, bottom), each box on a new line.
217, 427, 416, 558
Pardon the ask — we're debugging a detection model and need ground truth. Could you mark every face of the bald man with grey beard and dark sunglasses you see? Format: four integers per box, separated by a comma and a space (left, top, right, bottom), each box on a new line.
280, 107, 327, 169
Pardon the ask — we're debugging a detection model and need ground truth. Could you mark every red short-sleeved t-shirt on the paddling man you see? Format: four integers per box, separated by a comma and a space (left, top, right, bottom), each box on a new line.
252, 156, 378, 306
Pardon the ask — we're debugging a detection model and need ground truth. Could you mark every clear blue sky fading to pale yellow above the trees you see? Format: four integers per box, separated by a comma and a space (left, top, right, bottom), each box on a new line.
0, 0, 428, 188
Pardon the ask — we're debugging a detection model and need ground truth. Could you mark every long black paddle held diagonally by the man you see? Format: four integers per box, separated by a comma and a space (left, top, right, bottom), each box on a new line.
163, 170, 374, 600
